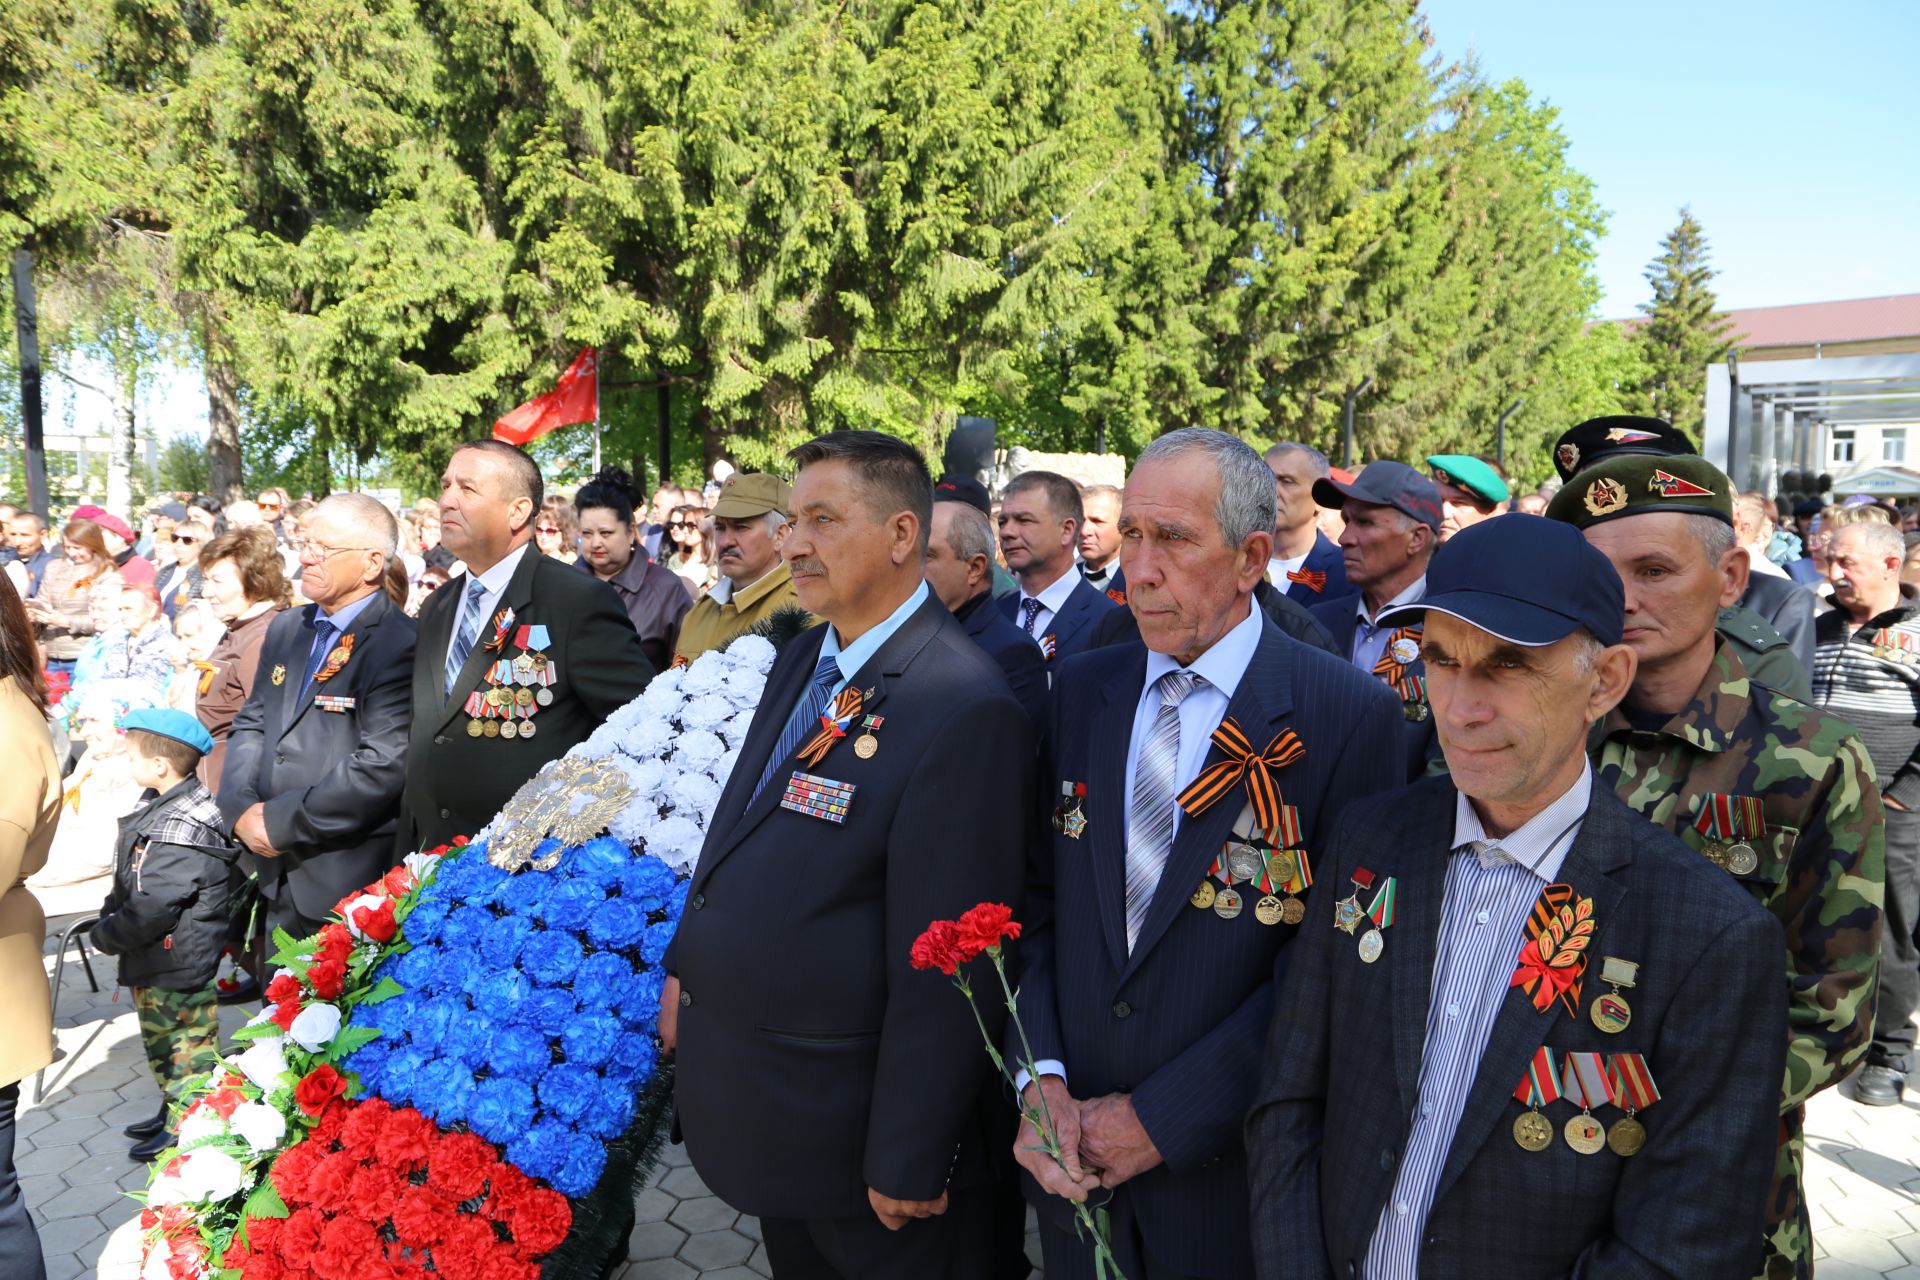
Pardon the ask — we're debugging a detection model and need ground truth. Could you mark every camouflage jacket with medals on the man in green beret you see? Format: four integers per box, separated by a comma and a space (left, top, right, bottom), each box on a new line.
1588, 645, 1885, 1280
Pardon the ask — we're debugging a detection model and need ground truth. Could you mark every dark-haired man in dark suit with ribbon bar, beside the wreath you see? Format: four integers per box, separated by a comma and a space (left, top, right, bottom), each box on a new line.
660, 432, 1033, 1280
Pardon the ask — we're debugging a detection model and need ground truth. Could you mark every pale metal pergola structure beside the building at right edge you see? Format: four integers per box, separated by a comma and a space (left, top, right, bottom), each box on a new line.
1701, 353, 1920, 493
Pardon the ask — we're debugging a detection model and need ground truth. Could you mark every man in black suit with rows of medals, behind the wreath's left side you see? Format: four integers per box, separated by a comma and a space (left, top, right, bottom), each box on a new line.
403, 439, 653, 852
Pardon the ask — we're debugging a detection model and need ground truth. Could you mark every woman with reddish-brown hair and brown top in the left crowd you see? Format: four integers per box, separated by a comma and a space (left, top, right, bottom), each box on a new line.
194, 526, 292, 794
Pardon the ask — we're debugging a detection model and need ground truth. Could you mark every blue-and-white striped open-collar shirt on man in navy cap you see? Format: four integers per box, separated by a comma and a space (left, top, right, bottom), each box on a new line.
1365, 766, 1594, 1280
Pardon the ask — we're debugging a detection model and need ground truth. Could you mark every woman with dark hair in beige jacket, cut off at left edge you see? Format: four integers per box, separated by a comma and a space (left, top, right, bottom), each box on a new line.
0, 583, 60, 1280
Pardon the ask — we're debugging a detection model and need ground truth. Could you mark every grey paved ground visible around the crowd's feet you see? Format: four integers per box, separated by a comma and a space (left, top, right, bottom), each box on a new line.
19, 905, 1920, 1280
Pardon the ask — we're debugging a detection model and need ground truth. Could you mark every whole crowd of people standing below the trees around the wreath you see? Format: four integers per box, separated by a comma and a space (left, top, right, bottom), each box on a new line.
0, 416, 1920, 1280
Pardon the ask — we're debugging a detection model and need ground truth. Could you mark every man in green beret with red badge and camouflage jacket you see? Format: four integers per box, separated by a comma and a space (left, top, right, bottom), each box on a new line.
1548, 455, 1885, 1280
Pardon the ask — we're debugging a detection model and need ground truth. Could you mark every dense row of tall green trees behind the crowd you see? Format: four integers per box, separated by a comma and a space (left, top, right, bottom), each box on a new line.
0, 0, 1651, 487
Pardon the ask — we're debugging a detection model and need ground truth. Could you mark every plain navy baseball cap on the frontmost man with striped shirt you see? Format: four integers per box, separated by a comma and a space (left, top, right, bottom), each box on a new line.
1369, 514, 1626, 649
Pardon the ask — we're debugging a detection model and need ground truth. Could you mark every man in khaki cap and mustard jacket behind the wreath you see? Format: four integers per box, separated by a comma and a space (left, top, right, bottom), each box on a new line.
674, 472, 799, 662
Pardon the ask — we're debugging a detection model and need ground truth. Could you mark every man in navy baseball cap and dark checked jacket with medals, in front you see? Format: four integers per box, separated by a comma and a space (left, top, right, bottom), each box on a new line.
1246, 514, 1786, 1280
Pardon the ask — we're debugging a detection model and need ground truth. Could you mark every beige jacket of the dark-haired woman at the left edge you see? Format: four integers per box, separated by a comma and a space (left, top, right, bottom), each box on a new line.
0, 677, 60, 1084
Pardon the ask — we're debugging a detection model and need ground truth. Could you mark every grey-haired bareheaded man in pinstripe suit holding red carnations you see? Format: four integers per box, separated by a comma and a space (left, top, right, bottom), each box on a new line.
1016, 430, 1400, 1280
